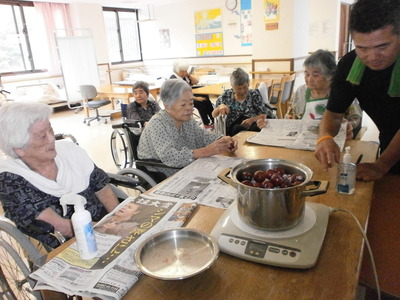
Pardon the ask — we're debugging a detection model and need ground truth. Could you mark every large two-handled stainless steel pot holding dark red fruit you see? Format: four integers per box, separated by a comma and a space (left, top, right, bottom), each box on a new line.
218, 159, 329, 231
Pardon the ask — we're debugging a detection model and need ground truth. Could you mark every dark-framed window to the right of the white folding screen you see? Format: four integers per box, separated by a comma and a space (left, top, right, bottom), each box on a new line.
103, 7, 142, 64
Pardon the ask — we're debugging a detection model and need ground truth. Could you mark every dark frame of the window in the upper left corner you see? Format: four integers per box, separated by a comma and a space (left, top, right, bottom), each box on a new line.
0, 0, 47, 76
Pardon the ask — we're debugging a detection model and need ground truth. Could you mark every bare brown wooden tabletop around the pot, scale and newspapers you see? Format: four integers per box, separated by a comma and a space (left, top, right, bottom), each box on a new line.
43, 132, 377, 300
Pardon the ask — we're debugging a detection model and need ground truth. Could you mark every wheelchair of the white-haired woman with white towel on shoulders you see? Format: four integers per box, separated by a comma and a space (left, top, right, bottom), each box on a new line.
0, 134, 156, 300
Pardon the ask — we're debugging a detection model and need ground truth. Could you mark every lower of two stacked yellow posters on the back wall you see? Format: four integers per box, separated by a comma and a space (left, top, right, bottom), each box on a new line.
196, 32, 224, 56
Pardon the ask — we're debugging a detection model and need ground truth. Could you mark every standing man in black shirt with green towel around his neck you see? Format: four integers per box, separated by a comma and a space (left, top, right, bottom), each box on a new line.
315, 0, 400, 181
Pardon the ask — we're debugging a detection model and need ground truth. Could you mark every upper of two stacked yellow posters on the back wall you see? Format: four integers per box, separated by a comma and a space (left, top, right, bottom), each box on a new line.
194, 8, 222, 33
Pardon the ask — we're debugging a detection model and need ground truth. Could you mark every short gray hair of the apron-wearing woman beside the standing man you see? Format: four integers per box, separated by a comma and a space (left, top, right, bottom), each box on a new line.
303, 49, 336, 80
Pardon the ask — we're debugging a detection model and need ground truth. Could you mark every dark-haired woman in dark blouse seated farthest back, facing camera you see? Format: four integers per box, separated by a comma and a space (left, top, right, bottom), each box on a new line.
126, 81, 160, 126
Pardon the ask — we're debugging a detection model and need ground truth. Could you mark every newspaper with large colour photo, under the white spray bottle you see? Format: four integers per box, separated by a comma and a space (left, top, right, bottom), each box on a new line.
30, 196, 196, 300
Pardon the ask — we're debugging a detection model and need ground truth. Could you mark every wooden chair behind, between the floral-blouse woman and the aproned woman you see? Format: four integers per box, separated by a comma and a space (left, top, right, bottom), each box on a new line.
269, 73, 296, 119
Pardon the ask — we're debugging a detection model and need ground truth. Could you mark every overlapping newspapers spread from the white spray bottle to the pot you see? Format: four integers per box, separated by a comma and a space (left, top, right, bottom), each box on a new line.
30, 155, 245, 300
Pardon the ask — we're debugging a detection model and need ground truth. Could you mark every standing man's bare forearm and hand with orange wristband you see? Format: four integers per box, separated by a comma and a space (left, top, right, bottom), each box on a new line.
314, 110, 343, 170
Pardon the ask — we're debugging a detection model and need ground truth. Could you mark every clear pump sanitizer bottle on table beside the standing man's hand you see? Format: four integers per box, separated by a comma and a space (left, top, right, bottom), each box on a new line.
336, 146, 357, 195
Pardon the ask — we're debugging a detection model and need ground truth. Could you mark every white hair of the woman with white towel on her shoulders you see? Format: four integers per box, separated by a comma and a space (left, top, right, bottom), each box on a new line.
0, 102, 53, 158
